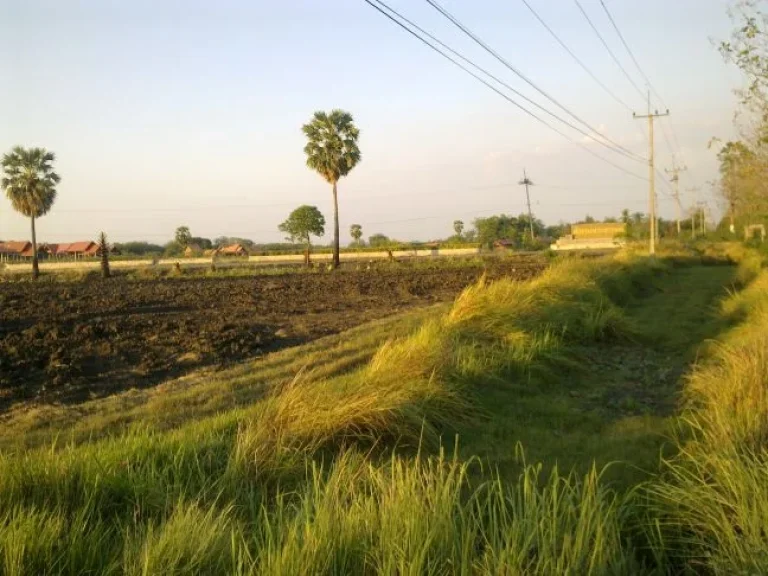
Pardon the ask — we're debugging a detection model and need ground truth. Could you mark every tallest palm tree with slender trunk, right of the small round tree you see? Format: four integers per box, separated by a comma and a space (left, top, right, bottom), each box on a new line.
302, 110, 360, 268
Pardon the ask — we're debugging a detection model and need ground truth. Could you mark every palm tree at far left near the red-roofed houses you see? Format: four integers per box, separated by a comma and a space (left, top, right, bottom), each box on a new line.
0, 146, 61, 279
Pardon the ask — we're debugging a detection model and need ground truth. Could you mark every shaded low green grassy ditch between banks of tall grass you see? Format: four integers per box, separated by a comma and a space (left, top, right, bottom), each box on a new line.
462, 266, 735, 486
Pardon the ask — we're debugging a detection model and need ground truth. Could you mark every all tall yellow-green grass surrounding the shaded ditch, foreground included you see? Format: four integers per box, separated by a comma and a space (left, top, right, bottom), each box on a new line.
0, 256, 768, 575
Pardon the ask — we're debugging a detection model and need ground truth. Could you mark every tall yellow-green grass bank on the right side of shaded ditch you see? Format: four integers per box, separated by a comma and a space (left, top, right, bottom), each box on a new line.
648, 272, 768, 574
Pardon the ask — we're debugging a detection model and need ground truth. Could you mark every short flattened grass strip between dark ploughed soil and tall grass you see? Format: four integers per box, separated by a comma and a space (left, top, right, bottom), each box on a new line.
0, 305, 447, 450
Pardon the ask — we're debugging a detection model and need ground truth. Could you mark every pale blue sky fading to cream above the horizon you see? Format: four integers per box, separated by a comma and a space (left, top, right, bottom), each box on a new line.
0, 0, 741, 243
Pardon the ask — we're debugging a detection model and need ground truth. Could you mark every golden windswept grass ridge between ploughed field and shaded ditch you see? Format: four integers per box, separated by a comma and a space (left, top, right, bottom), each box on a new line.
236, 261, 653, 476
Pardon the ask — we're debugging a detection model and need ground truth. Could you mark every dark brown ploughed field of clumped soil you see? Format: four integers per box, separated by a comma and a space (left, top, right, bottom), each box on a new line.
0, 261, 542, 410
